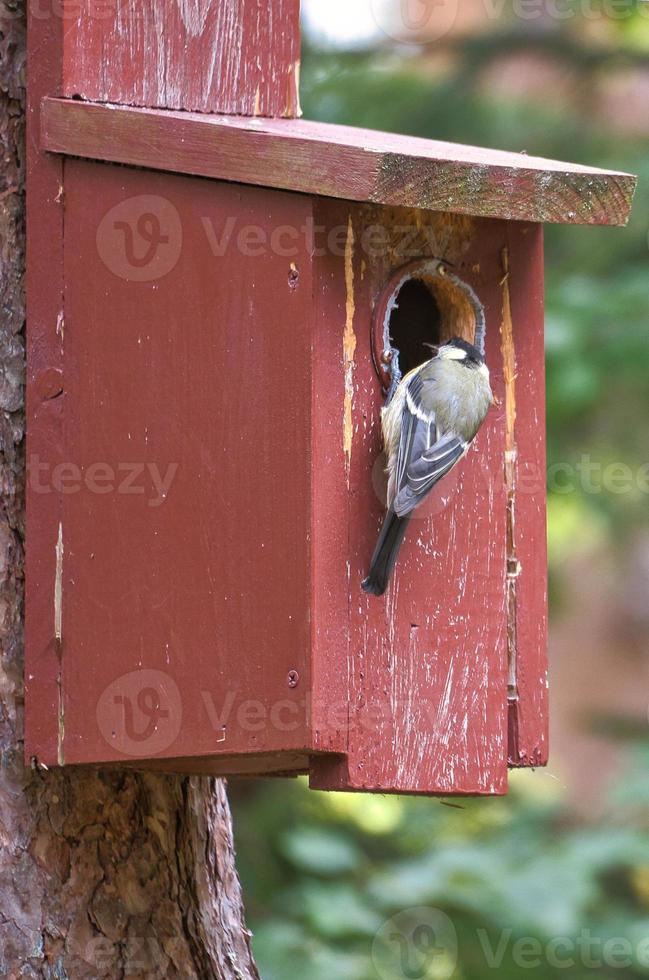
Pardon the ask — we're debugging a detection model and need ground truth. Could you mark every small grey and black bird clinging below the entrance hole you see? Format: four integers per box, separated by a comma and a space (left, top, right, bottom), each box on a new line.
361, 337, 494, 596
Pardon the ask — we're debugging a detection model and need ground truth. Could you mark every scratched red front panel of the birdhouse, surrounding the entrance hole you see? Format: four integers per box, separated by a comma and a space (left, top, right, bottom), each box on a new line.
311, 201, 547, 793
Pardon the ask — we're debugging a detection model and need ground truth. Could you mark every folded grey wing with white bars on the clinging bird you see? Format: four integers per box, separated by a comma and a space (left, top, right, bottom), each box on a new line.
392, 375, 469, 517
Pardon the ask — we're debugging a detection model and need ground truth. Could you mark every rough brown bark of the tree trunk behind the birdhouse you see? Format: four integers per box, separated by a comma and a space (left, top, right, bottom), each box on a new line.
0, 0, 258, 980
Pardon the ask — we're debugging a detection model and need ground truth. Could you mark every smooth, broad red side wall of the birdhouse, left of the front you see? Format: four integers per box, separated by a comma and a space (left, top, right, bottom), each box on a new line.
34, 161, 311, 769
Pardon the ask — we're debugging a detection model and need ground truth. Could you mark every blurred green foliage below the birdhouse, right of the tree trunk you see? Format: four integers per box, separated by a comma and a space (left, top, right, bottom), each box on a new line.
230, 752, 649, 980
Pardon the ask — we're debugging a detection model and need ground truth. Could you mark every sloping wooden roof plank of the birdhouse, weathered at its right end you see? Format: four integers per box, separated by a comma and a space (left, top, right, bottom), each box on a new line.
42, 99, 636, 225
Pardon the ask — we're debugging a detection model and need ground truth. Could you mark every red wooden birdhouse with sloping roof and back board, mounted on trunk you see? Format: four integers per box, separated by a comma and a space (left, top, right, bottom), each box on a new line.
26, 0, 634, 794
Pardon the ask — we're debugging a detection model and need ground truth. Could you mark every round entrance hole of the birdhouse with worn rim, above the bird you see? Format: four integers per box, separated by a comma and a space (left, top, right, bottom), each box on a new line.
373, 259, 485, 388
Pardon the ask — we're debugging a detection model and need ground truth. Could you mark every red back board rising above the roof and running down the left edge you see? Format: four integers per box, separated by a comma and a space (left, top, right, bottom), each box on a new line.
25, 0, 299, 762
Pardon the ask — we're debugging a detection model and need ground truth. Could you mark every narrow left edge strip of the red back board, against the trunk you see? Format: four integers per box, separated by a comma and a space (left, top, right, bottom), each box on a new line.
25, 6, 65, 760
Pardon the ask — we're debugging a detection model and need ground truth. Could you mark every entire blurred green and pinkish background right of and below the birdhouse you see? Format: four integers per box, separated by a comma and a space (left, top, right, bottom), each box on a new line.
230, 0, 649, 980
